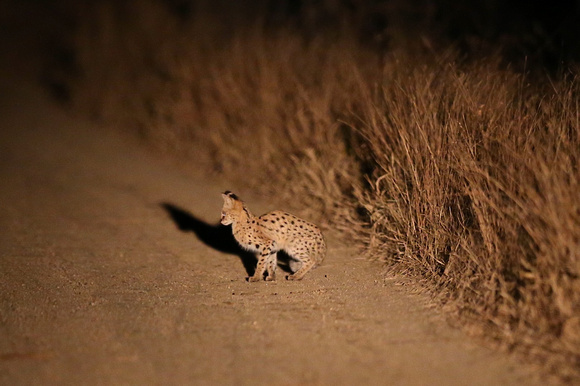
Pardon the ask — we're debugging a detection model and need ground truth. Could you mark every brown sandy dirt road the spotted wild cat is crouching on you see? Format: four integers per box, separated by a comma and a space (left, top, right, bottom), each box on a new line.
0, 6, 536, 385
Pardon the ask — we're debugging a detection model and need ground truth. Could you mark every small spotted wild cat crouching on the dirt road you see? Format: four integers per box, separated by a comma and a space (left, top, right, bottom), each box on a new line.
221, 191, 326, 281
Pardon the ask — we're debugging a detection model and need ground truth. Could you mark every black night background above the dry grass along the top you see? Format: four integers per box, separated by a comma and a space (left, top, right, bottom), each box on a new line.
0, 0, 580, 79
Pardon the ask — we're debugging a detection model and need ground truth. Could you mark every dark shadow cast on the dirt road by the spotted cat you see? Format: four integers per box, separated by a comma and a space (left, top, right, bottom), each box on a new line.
160, 202, 257, 276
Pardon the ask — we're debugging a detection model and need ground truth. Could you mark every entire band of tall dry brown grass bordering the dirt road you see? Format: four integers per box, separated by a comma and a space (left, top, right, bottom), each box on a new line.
60, 1, 580, 380
